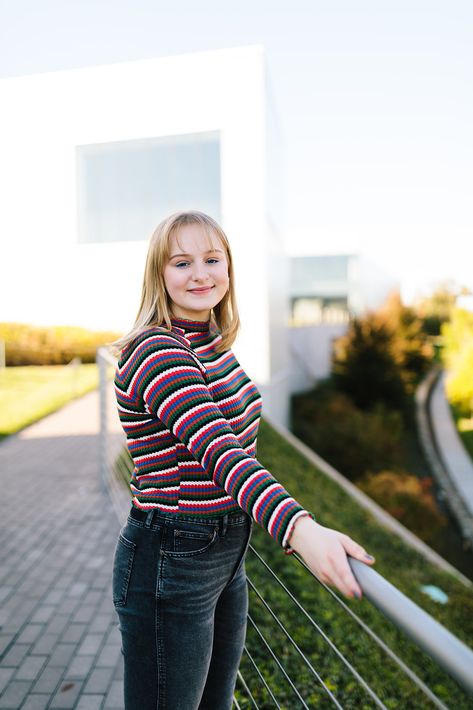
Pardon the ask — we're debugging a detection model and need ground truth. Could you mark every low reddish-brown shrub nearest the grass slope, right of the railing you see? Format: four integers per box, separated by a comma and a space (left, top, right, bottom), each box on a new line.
357, 471, 446, 540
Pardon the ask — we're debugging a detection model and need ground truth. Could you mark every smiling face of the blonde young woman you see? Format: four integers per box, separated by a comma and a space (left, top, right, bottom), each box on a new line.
164, 224, 228, 321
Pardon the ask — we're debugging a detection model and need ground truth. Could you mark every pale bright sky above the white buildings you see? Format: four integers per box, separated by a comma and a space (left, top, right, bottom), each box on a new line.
0, 0, 473, 302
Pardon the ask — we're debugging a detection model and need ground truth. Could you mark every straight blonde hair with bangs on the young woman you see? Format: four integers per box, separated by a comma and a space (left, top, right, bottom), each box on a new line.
112, 211, 240, 352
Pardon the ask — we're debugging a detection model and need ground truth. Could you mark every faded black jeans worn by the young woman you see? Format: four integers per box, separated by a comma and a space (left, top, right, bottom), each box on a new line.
113, 509, 251, 710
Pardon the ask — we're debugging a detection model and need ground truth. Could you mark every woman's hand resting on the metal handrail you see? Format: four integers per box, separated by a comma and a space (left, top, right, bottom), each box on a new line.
289, 516, 375, 599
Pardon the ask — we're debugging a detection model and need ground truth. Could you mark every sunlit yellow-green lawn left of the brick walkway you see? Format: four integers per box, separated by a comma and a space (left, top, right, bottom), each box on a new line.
0, 363, 98, 437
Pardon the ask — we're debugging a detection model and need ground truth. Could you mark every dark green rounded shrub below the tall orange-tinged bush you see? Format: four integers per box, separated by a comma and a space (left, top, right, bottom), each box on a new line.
292, 385, 403, 480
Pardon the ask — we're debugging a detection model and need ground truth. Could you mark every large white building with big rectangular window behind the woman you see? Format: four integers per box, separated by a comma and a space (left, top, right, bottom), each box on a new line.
0, 46, 289, 421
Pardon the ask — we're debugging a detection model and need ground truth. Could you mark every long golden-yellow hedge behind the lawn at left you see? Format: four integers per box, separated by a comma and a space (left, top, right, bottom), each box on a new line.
0, 323, 118, 366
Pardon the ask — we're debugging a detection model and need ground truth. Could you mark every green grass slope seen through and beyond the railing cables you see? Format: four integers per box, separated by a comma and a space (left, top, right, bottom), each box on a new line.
114, 422, 473, 710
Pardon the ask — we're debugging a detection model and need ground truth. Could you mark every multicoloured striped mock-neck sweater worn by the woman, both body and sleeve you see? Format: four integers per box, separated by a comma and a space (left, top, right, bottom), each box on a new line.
115, 319, 307, 547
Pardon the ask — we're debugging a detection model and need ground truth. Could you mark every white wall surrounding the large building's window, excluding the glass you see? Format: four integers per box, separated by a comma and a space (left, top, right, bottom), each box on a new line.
0, 47, 287, 428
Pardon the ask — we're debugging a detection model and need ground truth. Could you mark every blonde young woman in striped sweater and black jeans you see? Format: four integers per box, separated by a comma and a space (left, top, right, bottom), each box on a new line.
113, 212, 373, 710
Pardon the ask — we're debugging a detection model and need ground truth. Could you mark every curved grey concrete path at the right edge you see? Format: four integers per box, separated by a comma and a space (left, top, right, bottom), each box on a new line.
430, 372, 473, 515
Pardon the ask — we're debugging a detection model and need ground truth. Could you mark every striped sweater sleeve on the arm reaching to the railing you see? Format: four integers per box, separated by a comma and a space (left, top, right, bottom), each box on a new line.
132, 336, 307, 547
